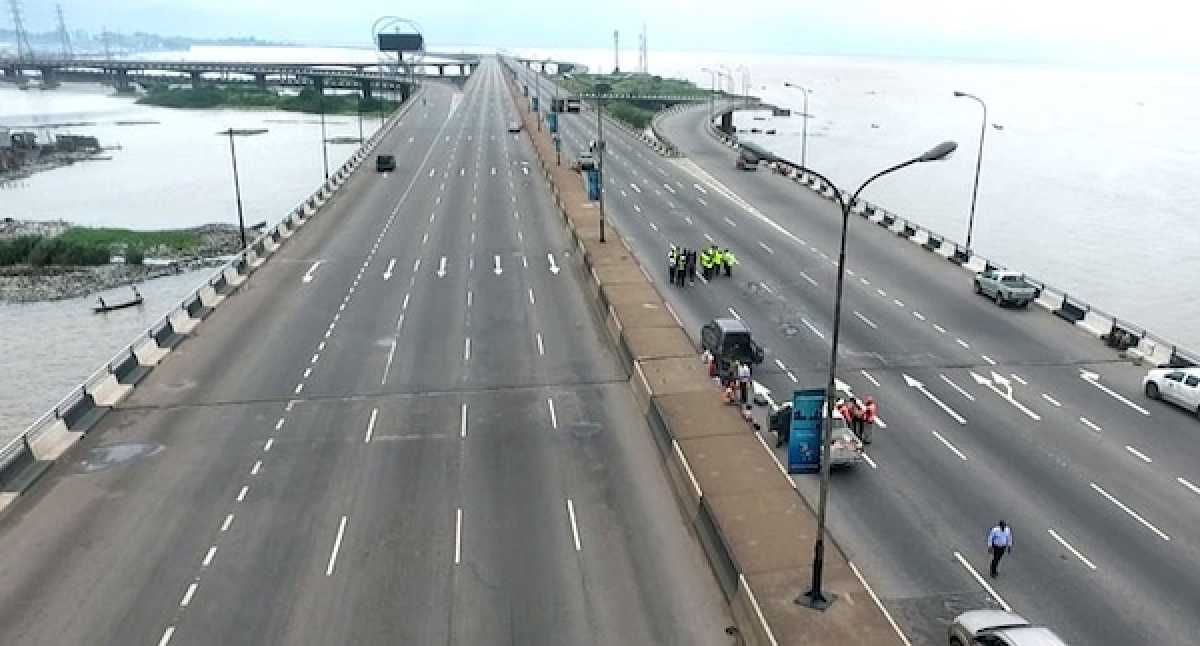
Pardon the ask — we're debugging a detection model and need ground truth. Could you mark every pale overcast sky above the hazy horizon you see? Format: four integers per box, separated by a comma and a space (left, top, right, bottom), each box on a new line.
14, 0, 1200, 65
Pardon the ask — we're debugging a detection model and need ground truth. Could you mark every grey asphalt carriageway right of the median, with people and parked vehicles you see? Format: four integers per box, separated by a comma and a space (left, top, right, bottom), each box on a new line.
522, 64, 1200, 645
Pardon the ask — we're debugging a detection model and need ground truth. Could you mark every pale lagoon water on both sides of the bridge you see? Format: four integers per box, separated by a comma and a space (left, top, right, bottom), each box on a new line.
0, 42, 1200, 437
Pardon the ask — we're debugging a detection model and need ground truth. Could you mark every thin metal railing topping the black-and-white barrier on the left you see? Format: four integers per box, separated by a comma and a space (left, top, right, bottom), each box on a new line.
0, 84, 421, 474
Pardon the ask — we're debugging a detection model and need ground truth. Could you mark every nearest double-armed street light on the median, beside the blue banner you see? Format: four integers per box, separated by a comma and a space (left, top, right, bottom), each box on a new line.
784, 142, 959, 610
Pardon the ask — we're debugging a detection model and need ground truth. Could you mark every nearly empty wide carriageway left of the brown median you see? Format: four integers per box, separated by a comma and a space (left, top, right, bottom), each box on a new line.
0, 61, 728, 644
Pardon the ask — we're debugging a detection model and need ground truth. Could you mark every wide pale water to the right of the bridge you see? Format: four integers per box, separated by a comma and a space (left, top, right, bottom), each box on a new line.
508, 49, 1200, 351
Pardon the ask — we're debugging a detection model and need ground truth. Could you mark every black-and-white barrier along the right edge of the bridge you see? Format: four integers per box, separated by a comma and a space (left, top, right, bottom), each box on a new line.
686, 102, 1200, 366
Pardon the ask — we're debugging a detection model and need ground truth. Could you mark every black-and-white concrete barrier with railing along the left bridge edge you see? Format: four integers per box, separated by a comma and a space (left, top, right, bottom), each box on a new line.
0, 81, 429, 492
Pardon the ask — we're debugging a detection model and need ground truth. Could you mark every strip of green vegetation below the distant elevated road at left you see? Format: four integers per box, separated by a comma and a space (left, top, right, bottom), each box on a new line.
138, 85, 400, 114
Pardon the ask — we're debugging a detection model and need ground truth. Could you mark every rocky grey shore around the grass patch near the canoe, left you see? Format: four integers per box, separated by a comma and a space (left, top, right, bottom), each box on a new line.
0, 220, 248, 303
